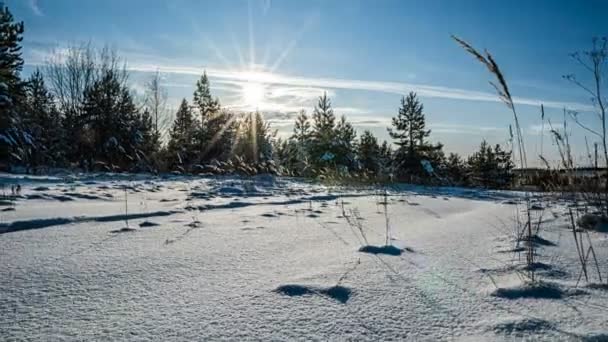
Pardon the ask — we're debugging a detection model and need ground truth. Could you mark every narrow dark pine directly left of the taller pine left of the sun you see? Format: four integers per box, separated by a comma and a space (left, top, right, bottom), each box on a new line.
167, 99, 197, 170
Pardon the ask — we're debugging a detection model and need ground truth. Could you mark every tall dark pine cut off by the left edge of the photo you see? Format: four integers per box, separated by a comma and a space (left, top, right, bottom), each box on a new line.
0, 6, 24, 169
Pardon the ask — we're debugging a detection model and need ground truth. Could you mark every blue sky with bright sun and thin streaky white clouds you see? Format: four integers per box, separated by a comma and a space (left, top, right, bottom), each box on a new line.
5, 0, 608, 164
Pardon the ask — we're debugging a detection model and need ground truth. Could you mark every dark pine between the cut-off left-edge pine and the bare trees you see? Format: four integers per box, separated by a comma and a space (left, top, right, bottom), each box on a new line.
23, 70, 66, 166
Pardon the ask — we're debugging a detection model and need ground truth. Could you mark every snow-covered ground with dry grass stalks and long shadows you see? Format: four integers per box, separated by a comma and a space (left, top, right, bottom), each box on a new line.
0, 174, 608, 341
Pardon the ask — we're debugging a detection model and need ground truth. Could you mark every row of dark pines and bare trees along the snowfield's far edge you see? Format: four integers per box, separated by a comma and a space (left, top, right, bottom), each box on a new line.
0, 7, 513, 187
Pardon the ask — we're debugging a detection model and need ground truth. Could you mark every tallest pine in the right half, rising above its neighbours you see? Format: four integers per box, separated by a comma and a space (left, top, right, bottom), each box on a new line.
388, 92, 441, 180
